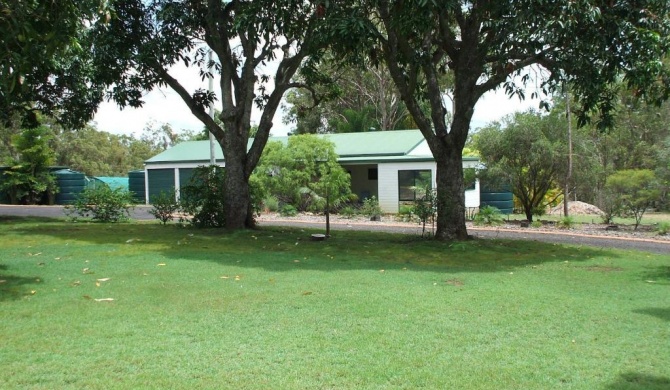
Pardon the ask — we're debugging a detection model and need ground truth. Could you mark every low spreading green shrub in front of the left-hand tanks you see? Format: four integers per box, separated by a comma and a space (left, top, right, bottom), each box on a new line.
66, 185, 133, 222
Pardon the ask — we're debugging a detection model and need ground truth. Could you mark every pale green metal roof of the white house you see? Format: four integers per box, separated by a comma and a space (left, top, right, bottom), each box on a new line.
146, 130, 430, 164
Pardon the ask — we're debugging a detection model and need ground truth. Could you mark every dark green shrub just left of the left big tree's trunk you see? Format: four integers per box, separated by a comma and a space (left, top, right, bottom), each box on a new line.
180, 165, 226, 227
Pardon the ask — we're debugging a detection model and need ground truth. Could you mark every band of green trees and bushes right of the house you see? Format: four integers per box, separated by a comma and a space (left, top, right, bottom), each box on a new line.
471, 92, 670, 220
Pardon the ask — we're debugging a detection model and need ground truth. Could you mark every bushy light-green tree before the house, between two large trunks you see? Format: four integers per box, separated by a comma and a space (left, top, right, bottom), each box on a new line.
254, 134, 353, 211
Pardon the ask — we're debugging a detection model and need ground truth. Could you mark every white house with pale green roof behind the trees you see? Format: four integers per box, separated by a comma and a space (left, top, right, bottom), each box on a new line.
144, 130, 479, 213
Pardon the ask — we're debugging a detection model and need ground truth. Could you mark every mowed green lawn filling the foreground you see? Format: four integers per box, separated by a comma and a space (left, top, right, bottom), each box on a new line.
0, 219, 670, 389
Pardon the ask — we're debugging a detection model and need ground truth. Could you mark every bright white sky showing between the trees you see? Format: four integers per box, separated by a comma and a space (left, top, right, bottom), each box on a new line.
93, 62, 539, 136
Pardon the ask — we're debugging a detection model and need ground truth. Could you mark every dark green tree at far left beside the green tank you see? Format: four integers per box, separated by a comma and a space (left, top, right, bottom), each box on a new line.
0, 126, 56, 204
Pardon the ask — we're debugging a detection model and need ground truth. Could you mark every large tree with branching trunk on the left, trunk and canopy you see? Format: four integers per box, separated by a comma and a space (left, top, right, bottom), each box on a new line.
92, 0, 362, 228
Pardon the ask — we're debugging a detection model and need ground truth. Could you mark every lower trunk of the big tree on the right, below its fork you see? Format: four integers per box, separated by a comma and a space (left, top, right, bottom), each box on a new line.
435, 148, 468, 240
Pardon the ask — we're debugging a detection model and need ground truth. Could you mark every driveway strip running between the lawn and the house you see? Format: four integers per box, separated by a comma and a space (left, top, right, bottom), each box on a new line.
0, 205, 670, 254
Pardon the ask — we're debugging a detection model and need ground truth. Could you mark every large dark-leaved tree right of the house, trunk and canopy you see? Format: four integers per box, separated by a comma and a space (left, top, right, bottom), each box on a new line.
345, 0, 670, 239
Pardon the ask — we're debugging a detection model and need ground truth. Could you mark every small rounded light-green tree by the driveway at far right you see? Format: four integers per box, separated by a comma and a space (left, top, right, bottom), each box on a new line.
605, 169, 660, 230
